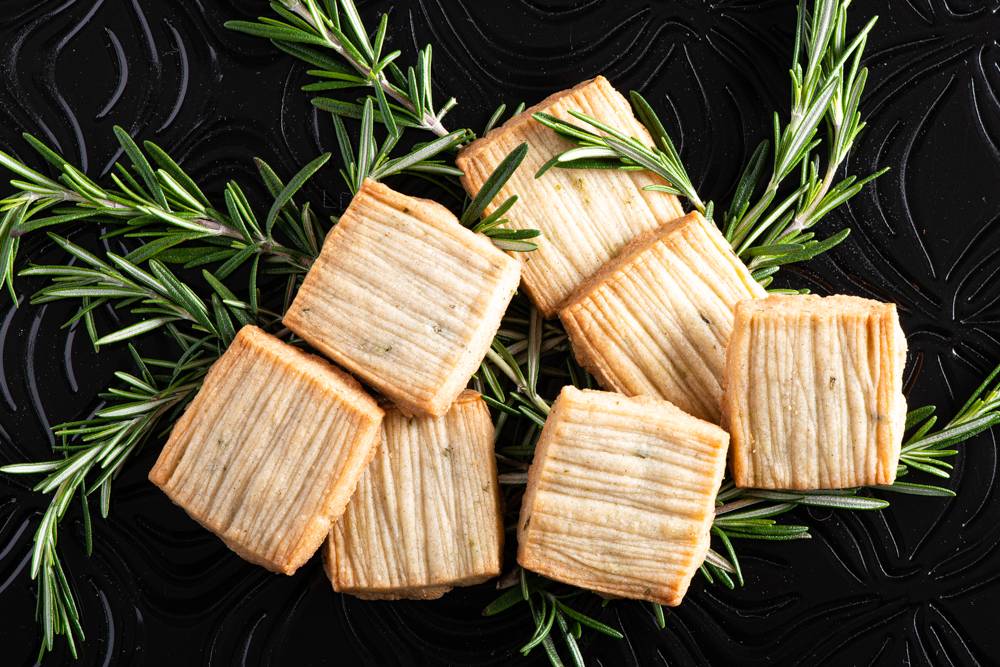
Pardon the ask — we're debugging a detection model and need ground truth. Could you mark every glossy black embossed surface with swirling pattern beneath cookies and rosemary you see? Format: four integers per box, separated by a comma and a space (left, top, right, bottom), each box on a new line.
0, 0, 1000, 666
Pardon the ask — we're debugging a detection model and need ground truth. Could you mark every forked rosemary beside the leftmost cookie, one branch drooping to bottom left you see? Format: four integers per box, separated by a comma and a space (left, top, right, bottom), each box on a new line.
0, 235, 280, 659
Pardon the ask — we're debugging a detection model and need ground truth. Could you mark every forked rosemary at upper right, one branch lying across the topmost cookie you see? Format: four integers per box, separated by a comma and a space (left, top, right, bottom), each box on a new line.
534, 0, 887, 286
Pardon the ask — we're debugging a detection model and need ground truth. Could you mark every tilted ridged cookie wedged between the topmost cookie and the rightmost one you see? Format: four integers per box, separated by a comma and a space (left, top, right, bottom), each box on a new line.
559, 213, 766, 423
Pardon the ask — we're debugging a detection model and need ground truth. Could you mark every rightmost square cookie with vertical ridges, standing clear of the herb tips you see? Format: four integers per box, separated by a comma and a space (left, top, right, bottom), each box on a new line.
723, 295, 906, 489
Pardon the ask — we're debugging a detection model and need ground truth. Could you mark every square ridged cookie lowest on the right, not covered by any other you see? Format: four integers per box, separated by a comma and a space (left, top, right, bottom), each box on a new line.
517, 387, 729, 605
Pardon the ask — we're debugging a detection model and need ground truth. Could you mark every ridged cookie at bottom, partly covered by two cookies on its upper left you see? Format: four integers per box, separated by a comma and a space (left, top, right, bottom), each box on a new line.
325, 391, 503, 599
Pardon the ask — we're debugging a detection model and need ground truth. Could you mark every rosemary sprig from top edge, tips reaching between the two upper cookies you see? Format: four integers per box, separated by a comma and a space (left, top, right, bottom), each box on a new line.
226, 0, 539, 252
